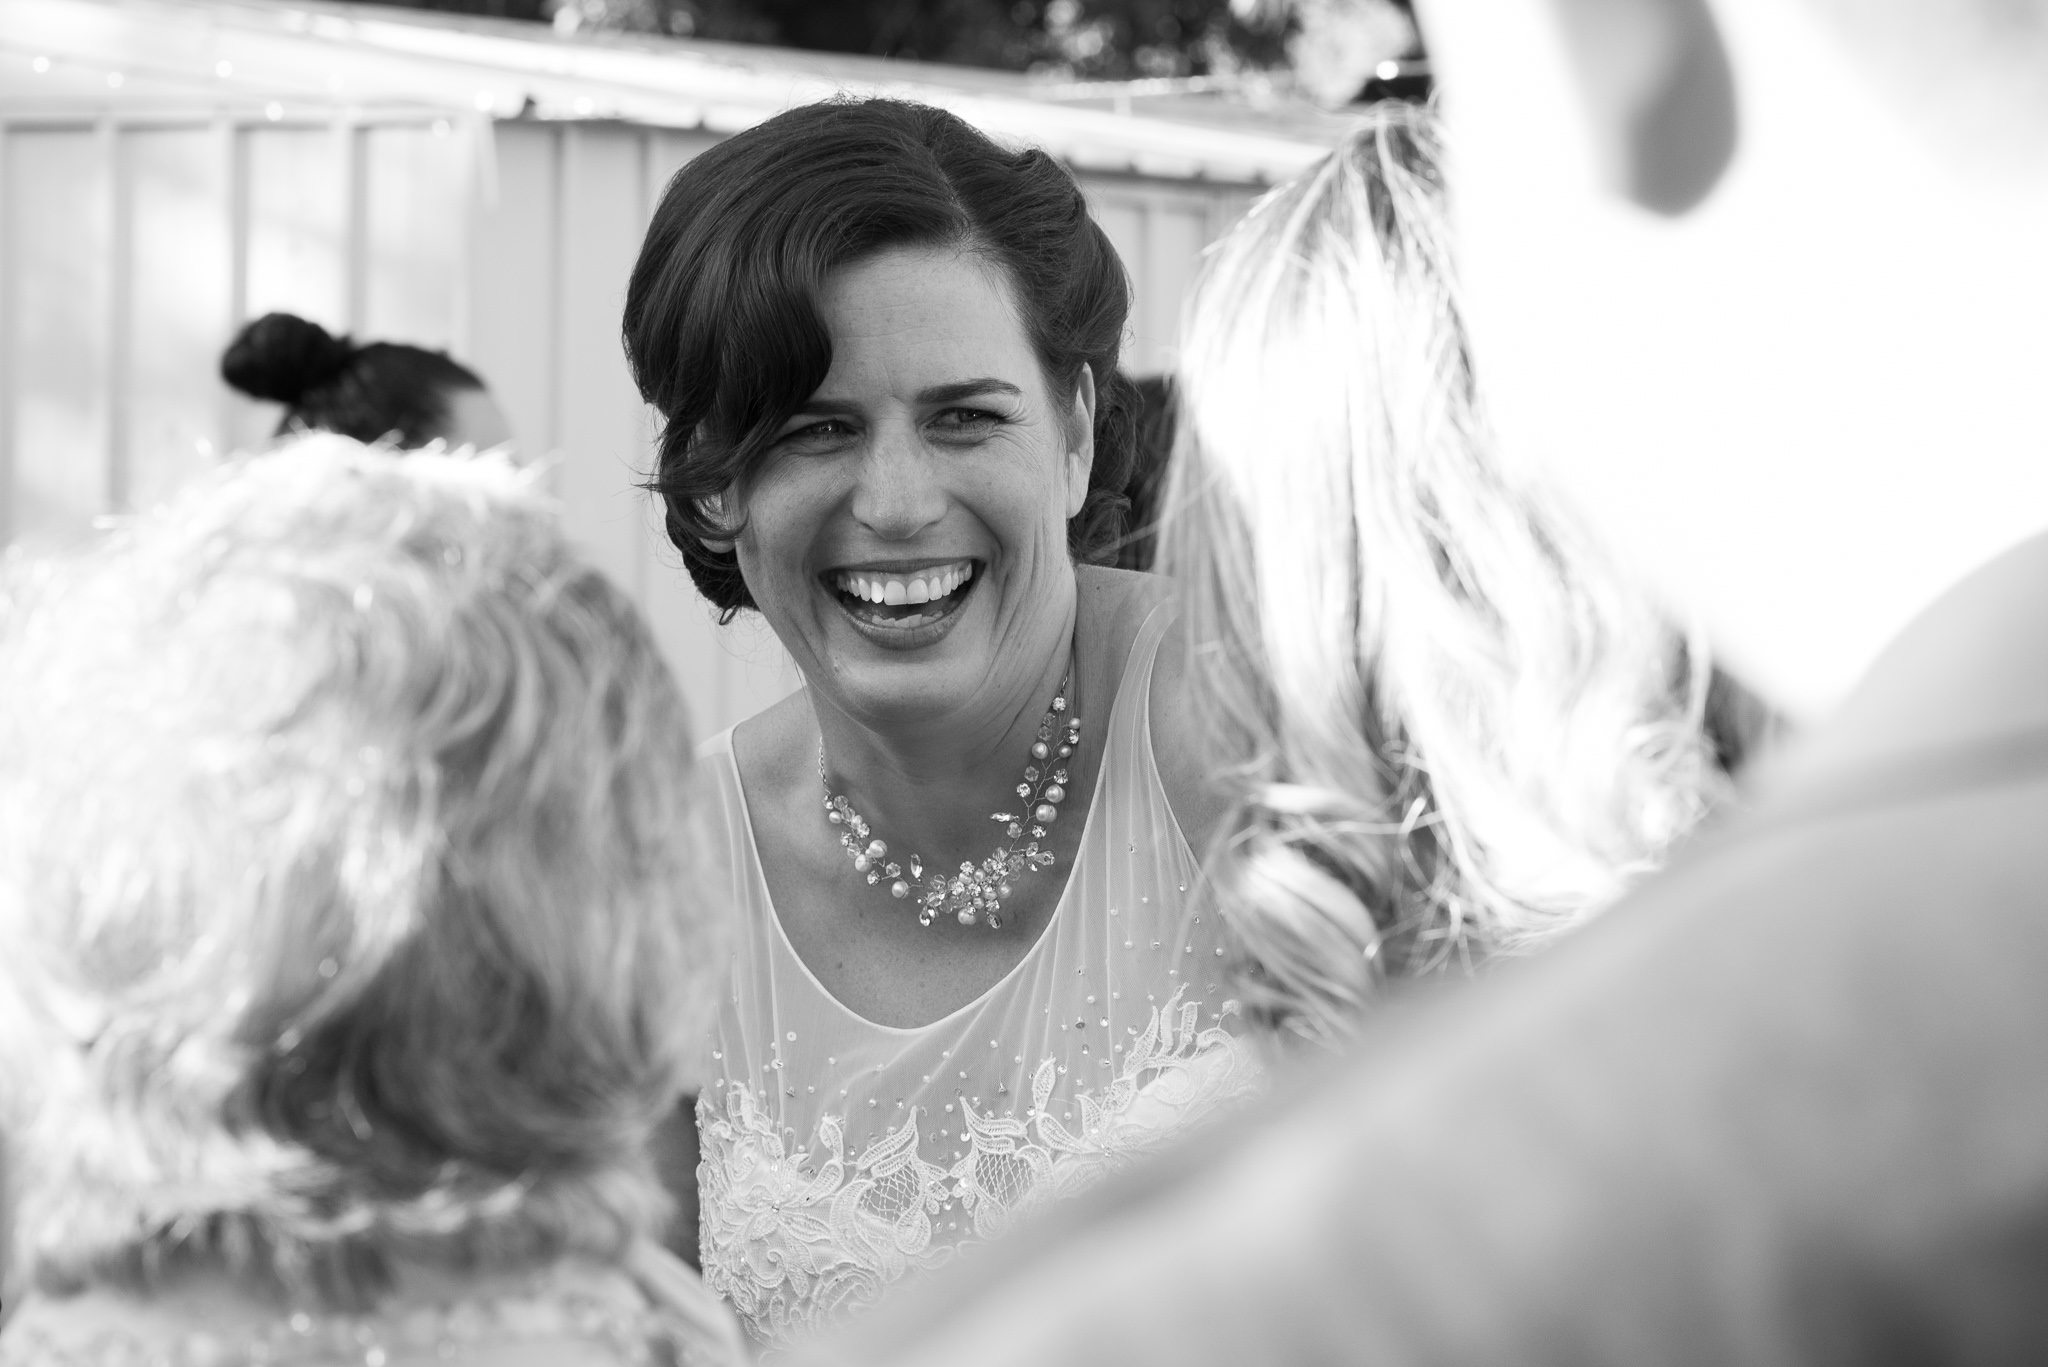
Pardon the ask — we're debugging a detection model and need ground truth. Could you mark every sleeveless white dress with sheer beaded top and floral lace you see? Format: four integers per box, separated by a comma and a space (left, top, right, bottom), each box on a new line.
696, 611, 1260, 1344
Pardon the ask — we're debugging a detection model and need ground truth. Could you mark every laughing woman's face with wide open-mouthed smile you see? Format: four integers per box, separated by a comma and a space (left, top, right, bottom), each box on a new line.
735, 248, 1094, 726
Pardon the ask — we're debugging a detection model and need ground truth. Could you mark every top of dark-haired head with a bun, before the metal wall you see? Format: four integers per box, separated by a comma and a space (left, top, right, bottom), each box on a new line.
221, 314, 512, 451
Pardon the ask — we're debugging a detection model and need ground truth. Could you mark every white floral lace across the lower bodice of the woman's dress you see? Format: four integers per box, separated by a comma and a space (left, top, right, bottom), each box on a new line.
698, 992, 1257, 1342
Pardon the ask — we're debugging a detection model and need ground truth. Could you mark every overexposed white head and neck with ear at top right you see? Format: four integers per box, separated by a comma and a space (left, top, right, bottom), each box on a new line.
1419, 0, 2048, 711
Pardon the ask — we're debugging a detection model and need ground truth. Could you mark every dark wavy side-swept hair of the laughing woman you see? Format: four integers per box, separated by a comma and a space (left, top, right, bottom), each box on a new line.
625, 100, 1137, 619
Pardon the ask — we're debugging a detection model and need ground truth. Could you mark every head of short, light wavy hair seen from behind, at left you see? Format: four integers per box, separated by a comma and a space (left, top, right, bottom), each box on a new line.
0, 437, 723, 1303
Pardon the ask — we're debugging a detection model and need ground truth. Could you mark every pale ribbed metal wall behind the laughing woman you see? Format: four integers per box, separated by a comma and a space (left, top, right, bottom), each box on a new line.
0, 111, 1251, 732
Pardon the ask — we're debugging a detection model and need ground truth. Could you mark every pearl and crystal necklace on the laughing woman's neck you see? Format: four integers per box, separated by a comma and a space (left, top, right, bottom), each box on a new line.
817, 674, 1081, 930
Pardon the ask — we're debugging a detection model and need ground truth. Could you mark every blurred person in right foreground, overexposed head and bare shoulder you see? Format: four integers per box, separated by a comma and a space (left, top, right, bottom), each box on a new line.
811, 0, 2048, 1367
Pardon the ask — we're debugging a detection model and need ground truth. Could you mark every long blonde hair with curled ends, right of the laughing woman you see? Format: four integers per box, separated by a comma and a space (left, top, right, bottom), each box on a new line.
1161, 105, 1716, 1039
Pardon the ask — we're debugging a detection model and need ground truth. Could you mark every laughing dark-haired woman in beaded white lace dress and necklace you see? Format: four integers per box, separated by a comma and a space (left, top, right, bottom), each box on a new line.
625, 100, 1255, 1340
